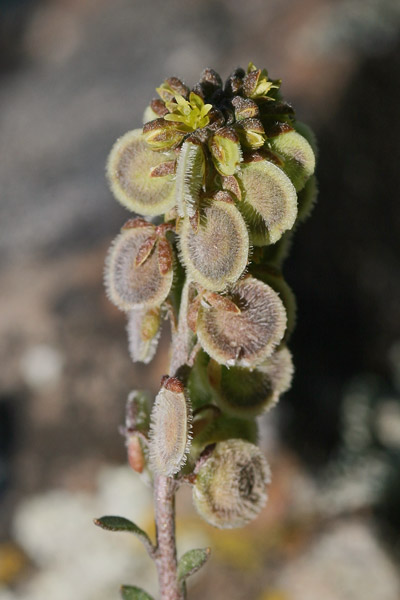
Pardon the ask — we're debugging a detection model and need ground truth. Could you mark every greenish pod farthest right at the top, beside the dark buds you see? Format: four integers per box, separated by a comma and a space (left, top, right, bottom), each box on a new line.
270, 131, 315, 192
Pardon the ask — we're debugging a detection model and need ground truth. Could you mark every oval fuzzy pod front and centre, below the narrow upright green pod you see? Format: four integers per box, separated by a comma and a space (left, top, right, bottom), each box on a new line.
180, 200, 249, 291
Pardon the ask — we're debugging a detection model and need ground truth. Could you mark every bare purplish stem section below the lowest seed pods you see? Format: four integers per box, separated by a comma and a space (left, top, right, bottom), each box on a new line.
154, 475, 184, 600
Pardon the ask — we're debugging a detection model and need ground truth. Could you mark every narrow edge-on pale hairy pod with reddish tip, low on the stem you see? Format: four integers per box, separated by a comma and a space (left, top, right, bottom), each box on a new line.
149, 377, 192, 477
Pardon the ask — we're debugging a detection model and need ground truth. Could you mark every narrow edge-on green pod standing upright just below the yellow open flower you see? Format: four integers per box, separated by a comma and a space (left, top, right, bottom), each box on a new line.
176, 141, 205, 217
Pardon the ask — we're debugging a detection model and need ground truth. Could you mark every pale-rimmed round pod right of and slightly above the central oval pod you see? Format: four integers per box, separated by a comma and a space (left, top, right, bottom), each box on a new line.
239, 160, 297, 245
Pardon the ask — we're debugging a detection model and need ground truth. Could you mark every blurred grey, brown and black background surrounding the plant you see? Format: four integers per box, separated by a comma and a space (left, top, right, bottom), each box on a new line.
0, 0, 400, 600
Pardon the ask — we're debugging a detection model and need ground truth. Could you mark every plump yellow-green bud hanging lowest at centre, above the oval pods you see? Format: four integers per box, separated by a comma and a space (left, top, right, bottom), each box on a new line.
209, 127, 242, 175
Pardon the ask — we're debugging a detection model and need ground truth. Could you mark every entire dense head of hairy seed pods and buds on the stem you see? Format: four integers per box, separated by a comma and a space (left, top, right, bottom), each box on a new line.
105, 63, 316, 528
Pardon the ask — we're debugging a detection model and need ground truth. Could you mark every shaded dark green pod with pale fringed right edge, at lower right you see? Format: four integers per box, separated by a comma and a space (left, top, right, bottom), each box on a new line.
214, 347, 293, 419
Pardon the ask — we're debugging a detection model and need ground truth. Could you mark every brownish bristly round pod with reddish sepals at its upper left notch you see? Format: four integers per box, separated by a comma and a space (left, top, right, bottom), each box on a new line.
197, 277, 286, 368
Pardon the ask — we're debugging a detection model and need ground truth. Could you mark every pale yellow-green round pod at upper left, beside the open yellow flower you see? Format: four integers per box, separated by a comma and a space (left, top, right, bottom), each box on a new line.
107, 129, 175, 216
